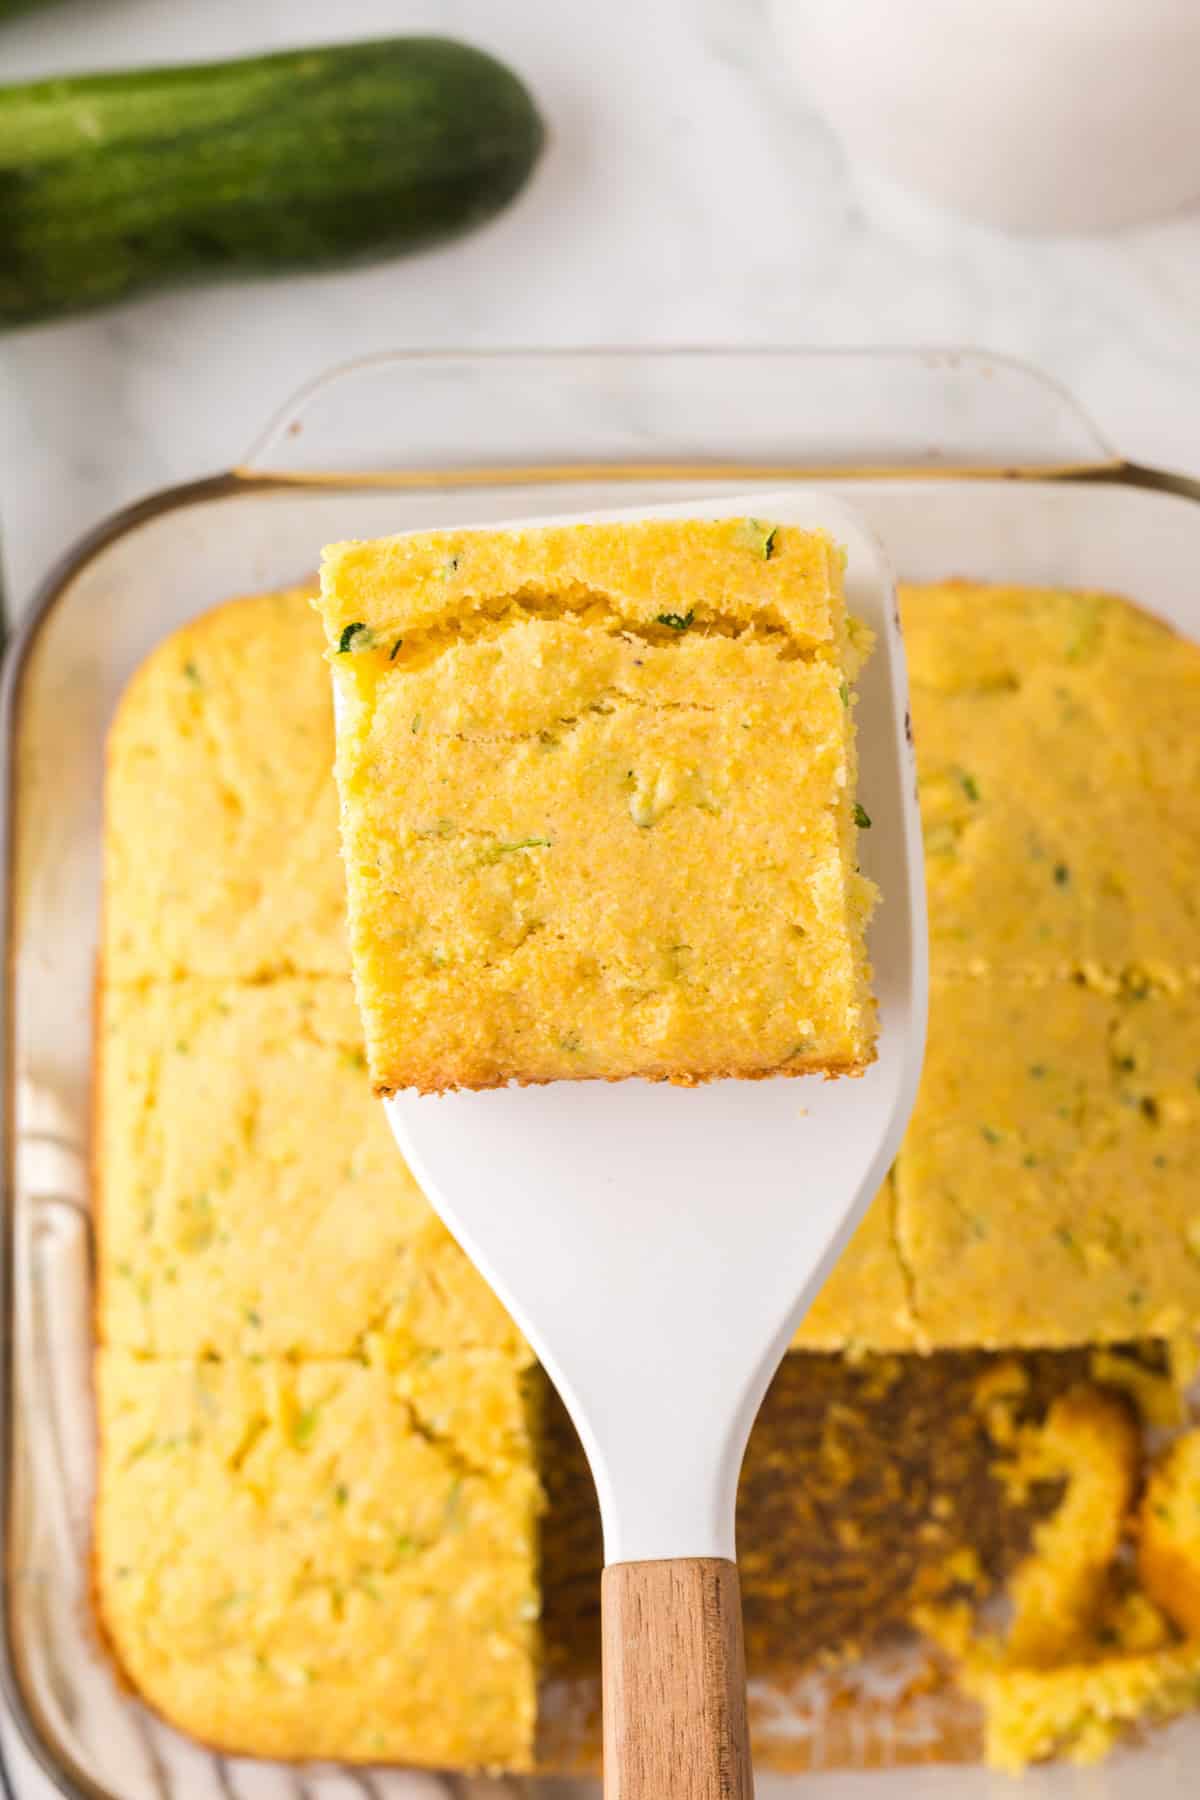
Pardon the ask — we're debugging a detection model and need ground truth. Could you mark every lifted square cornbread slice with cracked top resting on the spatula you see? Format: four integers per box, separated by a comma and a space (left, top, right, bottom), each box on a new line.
318, 518, 874, 1093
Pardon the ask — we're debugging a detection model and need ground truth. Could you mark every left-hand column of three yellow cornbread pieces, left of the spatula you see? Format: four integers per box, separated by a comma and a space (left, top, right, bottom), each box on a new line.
94, 589, 540, 1769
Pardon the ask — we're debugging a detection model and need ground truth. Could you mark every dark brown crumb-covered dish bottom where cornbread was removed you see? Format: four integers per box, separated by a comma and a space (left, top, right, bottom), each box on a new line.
540, 1350, 1087, 1684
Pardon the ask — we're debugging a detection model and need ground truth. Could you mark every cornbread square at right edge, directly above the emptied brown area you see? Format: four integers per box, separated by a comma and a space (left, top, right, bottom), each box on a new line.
894, 977, 1200, 1348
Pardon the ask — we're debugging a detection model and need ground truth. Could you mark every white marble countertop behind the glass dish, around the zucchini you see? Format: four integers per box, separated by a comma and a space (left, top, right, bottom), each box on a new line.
0, 0, 1200, 605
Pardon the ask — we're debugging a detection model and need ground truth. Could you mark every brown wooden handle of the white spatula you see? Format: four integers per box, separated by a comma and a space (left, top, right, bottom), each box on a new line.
603, 1557, 754, 1800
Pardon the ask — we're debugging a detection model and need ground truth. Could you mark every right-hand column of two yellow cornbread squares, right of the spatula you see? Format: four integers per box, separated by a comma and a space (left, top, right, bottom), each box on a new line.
892, 583, 1200, 1346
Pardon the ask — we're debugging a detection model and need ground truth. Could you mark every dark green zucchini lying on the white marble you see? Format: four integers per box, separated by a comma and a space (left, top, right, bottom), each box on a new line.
0, 38, 543, 326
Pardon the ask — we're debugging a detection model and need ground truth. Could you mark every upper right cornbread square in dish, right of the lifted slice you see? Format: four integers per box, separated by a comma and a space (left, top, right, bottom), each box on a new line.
901, 583, 1200, 985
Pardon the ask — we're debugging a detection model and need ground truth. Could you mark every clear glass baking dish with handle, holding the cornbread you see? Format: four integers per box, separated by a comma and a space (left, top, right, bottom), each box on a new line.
0, 351, 1200, 1800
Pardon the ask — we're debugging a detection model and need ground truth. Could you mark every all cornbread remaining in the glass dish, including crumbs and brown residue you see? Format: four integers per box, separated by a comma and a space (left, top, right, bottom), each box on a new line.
95, 585, 1200, 1769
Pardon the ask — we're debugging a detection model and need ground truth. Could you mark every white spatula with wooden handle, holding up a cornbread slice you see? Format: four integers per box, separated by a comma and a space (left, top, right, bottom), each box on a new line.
379, 491, 927, 1800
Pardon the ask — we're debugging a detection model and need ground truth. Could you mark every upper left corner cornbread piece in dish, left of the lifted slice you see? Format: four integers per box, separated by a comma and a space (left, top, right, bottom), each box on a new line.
101, 587, 349, 981
